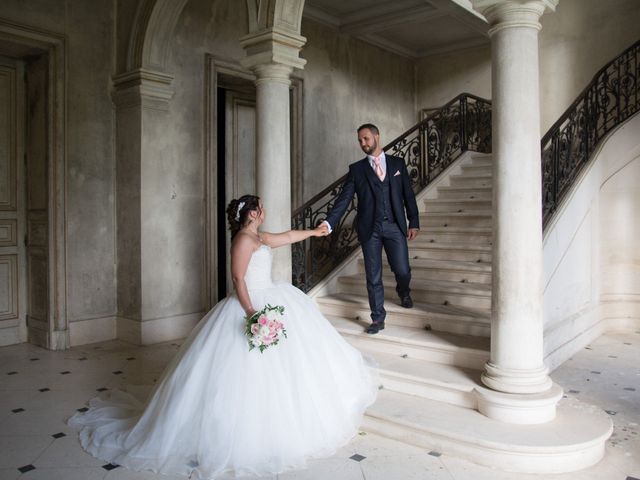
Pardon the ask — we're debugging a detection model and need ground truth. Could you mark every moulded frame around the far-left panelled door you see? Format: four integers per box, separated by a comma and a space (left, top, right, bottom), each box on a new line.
0, 19, 70, 350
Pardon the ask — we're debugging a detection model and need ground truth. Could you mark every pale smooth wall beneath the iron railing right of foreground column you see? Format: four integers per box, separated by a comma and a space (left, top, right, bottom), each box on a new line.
544, 115, 640, 367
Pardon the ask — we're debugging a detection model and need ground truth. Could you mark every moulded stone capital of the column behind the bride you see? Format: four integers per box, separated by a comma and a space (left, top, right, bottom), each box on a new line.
240, 28, 307, 75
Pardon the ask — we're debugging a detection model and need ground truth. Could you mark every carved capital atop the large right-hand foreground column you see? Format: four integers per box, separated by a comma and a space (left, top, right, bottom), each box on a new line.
471, 0, 560, 36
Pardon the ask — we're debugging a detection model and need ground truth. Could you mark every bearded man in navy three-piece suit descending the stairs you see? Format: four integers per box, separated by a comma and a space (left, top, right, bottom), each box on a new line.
325, 123, 420, 334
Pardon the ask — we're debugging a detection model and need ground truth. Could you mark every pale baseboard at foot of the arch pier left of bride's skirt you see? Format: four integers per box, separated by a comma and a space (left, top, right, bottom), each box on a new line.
117, 312, 205, 345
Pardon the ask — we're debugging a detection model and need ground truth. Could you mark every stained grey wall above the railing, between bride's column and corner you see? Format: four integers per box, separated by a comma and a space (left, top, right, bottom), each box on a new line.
301, 19, 416, 200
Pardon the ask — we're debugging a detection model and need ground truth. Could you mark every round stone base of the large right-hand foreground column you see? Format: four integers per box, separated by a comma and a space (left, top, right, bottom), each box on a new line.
475, 382, 563, 425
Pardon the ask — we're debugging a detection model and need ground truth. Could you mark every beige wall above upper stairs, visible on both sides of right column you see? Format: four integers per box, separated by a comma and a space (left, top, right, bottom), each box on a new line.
416, 0, 640, 134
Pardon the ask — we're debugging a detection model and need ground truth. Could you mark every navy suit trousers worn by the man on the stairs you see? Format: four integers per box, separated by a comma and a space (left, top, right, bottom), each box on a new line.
361, 221, 411, 322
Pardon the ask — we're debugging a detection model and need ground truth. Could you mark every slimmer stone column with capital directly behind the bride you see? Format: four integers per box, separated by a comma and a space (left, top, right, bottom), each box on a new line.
241, 29, 306, 282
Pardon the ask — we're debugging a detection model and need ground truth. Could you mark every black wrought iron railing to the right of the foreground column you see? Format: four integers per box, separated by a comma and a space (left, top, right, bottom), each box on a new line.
541, 41, 640, 226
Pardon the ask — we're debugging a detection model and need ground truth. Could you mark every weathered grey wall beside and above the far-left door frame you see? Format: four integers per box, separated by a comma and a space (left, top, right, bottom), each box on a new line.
0, 0, 116, 344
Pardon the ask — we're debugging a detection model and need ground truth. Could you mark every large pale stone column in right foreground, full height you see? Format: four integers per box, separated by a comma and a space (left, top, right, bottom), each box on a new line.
473, 0, 561, 423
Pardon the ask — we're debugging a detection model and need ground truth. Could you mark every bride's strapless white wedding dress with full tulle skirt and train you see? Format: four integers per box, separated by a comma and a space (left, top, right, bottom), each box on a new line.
69, 245, 377, 479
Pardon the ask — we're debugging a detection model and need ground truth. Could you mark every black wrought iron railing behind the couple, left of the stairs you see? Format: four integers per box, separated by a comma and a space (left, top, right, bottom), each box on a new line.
291, 93, 491, 292
